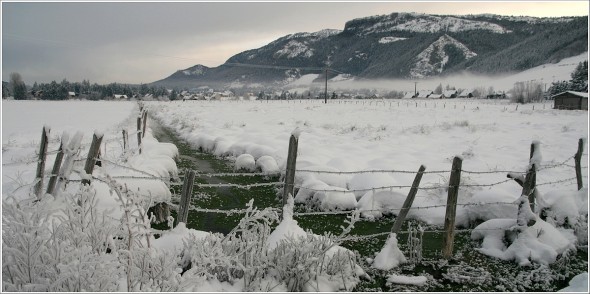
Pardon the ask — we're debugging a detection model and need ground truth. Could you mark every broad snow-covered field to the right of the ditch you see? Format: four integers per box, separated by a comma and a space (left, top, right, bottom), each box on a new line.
148, 99, 588, 272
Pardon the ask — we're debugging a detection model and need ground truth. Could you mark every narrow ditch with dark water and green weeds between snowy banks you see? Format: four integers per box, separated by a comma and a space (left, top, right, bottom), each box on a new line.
150, 118, 588, 292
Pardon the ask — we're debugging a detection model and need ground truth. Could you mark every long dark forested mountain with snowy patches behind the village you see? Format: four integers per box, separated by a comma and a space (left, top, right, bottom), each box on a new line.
153, 13, 588, 87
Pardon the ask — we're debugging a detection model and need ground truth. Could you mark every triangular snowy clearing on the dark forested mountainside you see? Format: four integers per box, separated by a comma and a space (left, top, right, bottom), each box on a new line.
410, 34, 477, 78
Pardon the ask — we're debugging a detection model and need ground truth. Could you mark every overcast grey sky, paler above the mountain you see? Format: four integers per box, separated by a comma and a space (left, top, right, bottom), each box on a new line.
2, 1, 588, 85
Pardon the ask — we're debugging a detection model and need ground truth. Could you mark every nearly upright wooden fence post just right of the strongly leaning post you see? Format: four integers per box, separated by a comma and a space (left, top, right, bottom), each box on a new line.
442, 156, 463, 259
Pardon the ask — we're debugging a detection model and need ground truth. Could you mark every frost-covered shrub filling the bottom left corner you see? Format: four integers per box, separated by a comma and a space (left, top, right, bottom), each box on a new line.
2, 186, 119, 291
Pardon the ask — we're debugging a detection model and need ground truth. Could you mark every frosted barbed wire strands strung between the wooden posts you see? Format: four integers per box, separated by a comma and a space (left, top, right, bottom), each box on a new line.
2, 107, 588, 249
